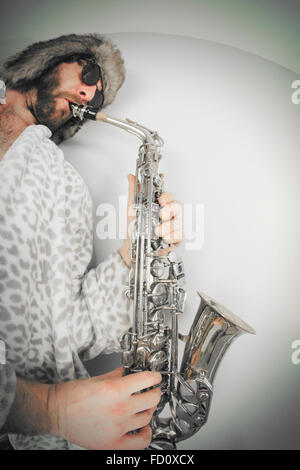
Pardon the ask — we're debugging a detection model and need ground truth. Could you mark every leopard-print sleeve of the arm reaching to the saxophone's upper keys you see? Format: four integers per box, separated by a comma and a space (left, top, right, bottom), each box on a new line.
71, 180, 132, 361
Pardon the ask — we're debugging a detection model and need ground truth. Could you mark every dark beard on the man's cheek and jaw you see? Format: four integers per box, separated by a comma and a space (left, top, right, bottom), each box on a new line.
33, 69, 71, 132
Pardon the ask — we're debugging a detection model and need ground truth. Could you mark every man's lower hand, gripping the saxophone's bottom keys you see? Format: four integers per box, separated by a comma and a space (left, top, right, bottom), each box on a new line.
48, 367, 161, 450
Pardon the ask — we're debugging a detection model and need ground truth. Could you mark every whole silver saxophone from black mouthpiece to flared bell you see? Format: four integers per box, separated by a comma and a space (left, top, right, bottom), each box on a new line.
70, 104, 255, 450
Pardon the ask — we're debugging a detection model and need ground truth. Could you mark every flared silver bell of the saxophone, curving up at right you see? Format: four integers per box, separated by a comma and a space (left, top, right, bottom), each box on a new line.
176, 292, 255, 442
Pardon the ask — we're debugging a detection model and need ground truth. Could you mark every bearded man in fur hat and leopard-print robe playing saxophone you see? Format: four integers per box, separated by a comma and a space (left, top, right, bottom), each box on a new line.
0, 35, 181, 449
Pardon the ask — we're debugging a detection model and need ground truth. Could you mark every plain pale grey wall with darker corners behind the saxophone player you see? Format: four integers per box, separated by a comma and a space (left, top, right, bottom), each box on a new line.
0, 0, 300, 449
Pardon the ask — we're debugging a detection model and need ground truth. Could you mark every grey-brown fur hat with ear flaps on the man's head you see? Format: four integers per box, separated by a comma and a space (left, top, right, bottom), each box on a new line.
0, 34, 125, 144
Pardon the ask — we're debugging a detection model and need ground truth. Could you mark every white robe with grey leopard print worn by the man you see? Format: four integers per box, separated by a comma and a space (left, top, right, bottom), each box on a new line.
0, 125, 132, 449
